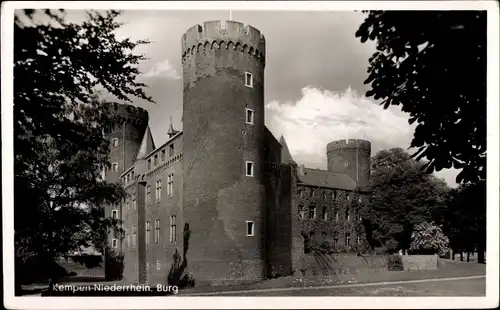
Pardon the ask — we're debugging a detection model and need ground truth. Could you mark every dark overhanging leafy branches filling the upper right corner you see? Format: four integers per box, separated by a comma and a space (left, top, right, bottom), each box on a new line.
356, 11, 486, 183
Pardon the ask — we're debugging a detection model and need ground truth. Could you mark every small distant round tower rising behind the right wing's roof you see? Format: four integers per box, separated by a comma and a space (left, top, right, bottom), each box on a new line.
326, 139, 371, 185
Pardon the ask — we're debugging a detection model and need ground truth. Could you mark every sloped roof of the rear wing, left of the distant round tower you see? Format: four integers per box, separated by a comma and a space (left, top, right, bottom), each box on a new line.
297, 168, 356, 190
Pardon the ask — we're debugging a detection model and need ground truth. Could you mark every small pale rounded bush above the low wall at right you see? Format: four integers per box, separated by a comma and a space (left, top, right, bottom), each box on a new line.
410, 222, 449, 255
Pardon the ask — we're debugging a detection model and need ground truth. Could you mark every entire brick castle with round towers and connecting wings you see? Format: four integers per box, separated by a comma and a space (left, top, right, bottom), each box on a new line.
105, 21, 371, 285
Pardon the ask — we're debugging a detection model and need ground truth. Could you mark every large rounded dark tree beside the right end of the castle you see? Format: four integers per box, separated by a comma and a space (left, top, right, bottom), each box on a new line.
363, 148, 448, 253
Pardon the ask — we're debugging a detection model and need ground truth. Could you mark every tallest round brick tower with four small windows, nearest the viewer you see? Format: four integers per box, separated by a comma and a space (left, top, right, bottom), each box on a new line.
182, 21, 265, 283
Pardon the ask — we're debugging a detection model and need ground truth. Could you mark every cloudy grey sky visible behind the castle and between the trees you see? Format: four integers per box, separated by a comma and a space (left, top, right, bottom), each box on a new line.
62, 10, 458, 187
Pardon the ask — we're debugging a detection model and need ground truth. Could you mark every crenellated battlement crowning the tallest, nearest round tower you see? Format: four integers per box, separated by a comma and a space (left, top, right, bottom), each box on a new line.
182, 21, 266, 62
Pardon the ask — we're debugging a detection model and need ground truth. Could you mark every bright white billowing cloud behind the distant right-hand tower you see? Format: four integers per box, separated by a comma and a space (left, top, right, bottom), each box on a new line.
266, 87, 457, 186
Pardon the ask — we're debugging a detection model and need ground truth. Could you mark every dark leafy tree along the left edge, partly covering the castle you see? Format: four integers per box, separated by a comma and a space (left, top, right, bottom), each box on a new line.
14, 10, 152, 280
